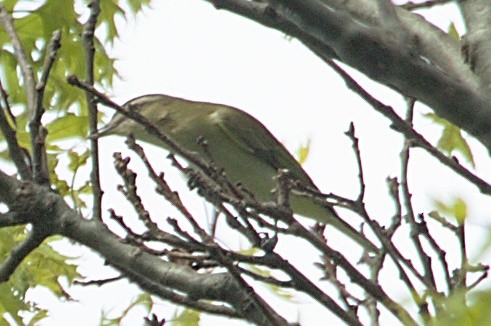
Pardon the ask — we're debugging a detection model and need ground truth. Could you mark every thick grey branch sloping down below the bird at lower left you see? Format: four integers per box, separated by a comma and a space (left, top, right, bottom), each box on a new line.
0, 171, 286, 325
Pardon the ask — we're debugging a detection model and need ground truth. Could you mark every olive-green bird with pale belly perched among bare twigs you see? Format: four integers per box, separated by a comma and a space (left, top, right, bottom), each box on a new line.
98, 95, 377, 252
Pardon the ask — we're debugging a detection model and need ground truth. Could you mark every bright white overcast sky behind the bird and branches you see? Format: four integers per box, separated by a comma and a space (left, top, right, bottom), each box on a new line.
20, 0, 491, 325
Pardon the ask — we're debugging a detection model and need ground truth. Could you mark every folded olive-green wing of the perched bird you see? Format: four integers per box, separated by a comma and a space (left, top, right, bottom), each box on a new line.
217, 107, 315, 187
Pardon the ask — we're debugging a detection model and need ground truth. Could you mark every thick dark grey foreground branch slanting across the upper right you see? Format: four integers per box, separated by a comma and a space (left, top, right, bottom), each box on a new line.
207, 0, 491, 152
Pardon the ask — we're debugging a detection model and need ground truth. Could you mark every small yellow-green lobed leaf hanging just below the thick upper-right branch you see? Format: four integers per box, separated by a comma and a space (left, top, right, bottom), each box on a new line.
425, 113, 475, 167
